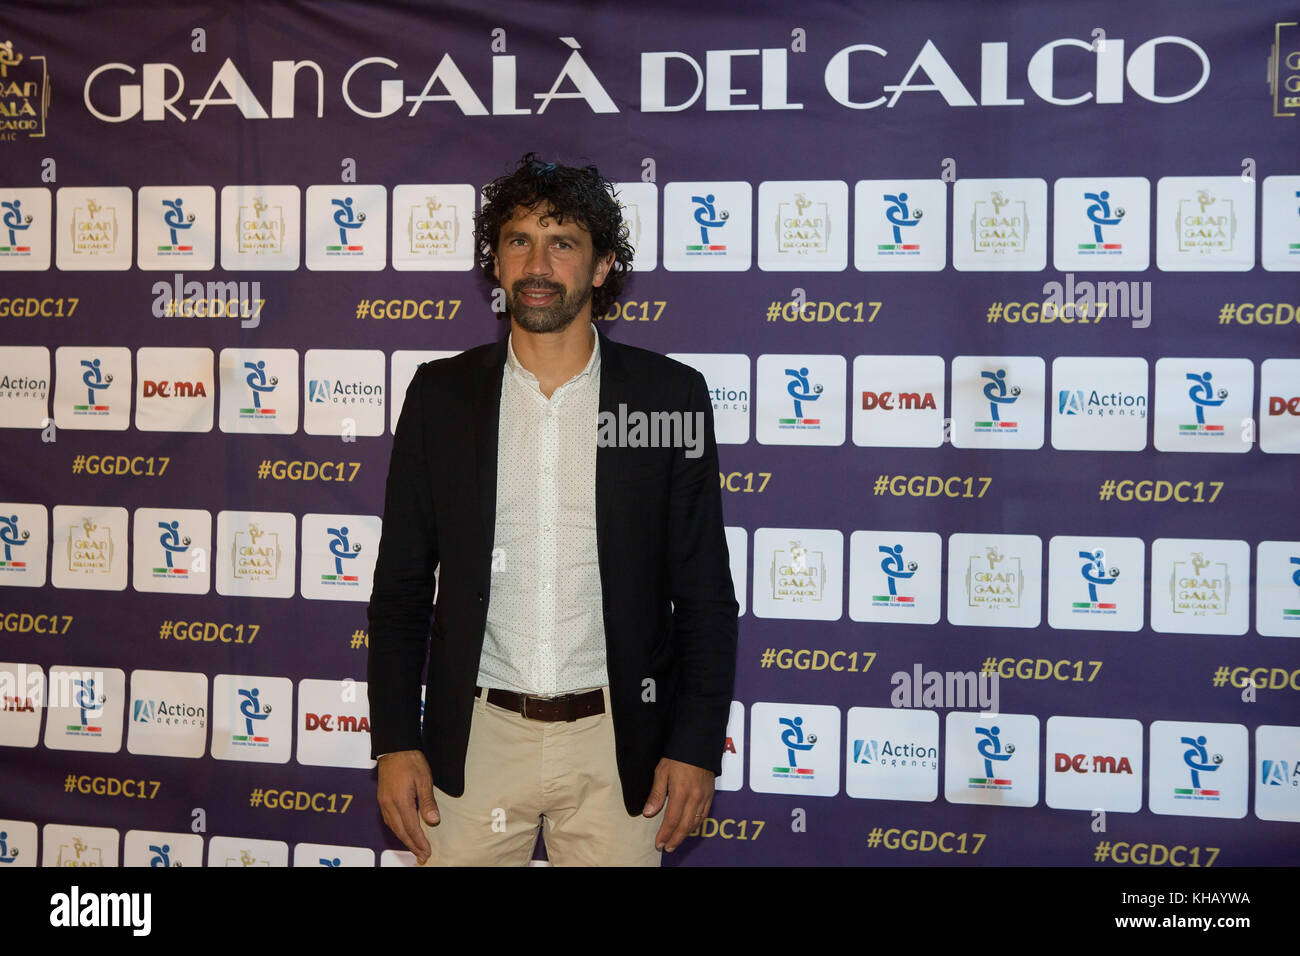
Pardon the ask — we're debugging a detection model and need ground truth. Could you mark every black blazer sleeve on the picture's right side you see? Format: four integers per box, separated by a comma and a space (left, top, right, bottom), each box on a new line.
663, 369, 740, 774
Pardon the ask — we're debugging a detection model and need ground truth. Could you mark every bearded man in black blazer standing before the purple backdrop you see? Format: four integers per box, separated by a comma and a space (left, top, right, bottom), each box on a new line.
369, 153, 738, 865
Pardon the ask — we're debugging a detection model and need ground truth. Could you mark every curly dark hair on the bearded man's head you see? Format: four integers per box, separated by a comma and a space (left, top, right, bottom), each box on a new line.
475, 152, 632, 317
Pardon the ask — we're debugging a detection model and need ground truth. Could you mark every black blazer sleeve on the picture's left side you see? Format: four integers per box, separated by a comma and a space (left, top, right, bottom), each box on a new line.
367, 365, 438, 758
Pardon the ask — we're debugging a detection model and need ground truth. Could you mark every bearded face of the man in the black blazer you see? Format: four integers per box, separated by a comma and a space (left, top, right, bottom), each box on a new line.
497, 207, 614, 332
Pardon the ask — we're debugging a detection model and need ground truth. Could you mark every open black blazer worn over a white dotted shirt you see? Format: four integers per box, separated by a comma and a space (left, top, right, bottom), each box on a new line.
368, 327, 738, 813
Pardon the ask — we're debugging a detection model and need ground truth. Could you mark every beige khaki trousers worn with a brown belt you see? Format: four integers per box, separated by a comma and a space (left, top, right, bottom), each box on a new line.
420, 687, 663, 866
